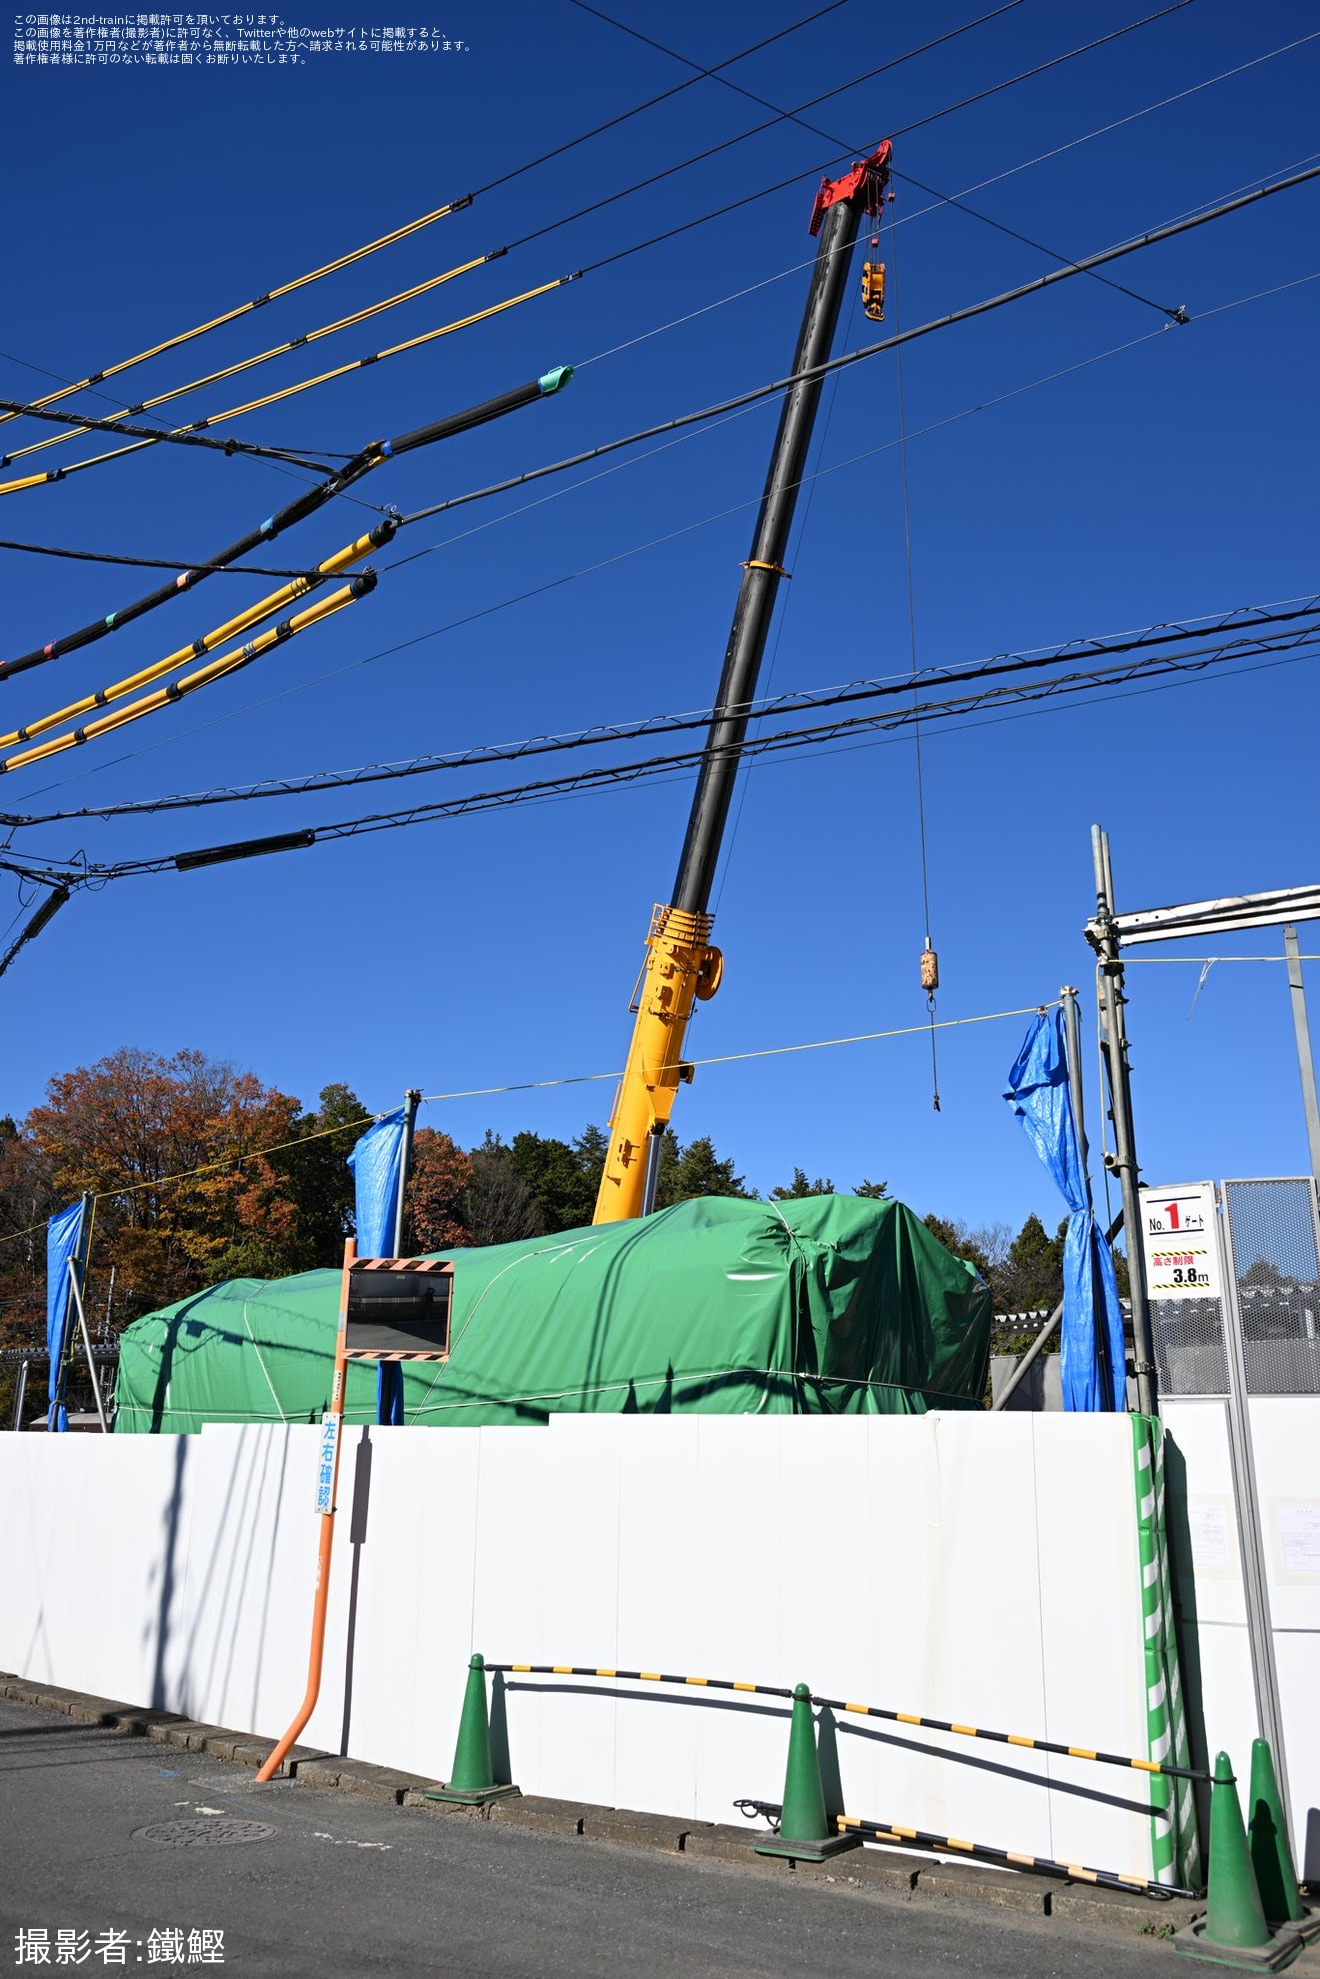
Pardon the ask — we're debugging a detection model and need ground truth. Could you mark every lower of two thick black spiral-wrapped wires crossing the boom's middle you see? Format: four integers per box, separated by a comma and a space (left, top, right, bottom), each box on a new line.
12, 625, 1320, 887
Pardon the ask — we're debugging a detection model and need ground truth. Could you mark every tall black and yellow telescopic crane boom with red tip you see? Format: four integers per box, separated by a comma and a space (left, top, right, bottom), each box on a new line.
592, 139, 891, 1223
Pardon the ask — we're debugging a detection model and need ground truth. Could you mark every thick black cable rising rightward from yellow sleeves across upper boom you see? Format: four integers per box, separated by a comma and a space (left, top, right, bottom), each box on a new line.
402, 162, 1320, 522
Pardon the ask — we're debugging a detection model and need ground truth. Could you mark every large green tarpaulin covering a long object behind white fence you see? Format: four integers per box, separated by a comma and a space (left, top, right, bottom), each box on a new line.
115, 1195, 991, 1433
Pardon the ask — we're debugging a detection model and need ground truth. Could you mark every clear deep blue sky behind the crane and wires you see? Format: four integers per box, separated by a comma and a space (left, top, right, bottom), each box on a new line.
0, 0, 1320, 1223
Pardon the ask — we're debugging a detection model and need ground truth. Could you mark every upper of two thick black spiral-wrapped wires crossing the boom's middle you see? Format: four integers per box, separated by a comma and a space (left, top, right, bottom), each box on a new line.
12, 594, 1320, 831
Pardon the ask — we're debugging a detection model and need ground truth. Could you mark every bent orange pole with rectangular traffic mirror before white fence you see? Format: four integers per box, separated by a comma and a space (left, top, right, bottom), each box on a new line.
257, 1237, 453, 1781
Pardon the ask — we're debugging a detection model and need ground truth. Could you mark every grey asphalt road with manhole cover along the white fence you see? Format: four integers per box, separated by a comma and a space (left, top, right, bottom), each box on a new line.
0, 1700, 1189, 1979
